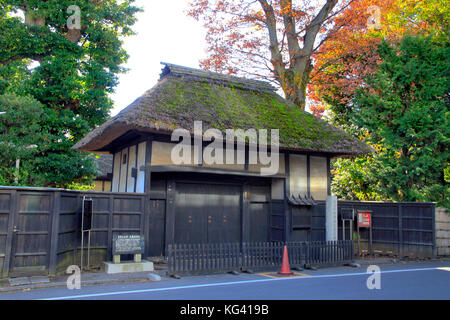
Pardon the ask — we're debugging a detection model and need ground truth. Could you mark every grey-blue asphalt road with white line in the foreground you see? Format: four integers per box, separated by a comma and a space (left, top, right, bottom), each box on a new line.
0, 262, 450, 300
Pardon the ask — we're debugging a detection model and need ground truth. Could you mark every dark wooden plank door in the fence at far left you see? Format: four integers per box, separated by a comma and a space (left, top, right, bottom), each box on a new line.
9, 192, 53, 276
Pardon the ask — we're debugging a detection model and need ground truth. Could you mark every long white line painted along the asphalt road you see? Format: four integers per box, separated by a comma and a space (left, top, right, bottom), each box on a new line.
38, 268, 442, 300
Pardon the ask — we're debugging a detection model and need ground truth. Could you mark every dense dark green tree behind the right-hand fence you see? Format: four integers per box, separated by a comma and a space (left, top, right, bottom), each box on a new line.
335, 36, 450, 207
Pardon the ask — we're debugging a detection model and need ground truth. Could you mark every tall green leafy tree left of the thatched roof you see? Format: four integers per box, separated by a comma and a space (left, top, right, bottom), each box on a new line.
0, 0, 140, 187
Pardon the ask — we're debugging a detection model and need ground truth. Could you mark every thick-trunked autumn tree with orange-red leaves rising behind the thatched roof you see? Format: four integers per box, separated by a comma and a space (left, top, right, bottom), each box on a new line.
188, 0, 406, 116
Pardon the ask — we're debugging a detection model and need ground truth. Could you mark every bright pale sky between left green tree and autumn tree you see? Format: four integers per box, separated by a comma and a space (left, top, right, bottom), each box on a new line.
111, 0, 206, 116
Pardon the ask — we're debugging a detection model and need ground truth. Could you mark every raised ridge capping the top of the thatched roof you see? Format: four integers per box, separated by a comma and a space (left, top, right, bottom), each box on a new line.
160, 62, 277, 92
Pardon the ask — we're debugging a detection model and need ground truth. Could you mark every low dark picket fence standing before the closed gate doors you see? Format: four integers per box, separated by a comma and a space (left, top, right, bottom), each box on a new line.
168, 240, 354, 274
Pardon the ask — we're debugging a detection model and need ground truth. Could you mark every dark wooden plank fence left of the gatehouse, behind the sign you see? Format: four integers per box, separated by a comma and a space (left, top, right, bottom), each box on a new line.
0, 187, 145, 277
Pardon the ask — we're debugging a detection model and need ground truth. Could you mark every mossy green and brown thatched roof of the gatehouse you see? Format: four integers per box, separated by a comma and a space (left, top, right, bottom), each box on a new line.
74, 63, 372, 155
